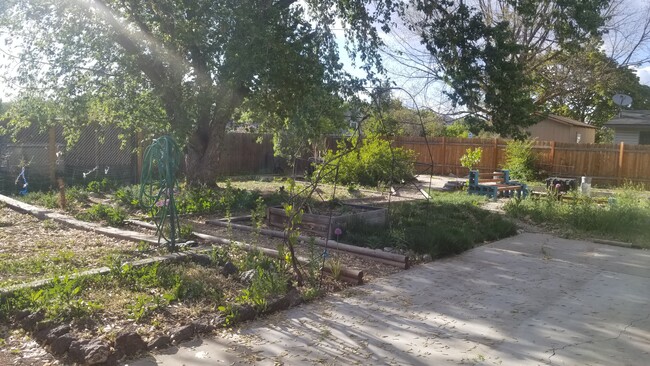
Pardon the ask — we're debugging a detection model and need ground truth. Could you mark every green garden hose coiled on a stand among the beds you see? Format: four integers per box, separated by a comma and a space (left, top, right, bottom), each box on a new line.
140, 135, 181, 252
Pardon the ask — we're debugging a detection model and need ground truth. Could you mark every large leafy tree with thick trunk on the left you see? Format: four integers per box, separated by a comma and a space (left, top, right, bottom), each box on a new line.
0, 0, 399, 183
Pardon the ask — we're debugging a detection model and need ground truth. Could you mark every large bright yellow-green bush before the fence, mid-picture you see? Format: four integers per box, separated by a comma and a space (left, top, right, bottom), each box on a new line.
319, 136, 415, 186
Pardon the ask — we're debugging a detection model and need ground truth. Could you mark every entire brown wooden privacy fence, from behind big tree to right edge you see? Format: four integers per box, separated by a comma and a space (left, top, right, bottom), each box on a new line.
130, 133, 650, 184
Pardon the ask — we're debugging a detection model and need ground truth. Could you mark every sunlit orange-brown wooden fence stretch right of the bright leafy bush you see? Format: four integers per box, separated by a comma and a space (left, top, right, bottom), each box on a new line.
394, 137, 650, 184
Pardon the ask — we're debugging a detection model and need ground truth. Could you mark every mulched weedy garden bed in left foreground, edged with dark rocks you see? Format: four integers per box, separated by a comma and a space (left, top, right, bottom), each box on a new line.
0, 197, 380, 365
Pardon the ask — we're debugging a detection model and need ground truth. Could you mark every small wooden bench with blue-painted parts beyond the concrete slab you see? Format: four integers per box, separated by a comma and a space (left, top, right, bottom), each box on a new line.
467, 170, 528, 200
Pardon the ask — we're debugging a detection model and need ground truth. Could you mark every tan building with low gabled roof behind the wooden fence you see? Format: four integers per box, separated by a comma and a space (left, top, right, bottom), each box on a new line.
526, 114, 596, 144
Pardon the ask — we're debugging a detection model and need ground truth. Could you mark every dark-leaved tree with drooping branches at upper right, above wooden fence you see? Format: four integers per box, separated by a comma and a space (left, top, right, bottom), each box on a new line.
412, 0, 609, 137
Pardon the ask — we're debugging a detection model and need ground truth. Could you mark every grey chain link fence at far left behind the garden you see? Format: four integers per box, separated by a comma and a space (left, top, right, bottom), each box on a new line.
0, 126, 137, 194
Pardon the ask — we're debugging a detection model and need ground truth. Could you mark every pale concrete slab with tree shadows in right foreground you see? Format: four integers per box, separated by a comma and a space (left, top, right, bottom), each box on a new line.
129, 233, 650, 366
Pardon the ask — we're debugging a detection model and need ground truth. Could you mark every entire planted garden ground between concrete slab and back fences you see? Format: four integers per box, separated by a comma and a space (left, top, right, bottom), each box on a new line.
0, 142, 650, 364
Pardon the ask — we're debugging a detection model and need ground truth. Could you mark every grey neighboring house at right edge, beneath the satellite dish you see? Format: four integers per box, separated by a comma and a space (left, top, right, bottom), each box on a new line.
605, 111, 650, 145
